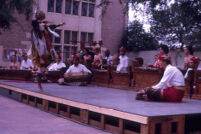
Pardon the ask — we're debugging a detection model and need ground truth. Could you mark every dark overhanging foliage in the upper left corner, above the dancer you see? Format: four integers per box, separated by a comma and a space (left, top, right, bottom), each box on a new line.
0, 0, 33, 32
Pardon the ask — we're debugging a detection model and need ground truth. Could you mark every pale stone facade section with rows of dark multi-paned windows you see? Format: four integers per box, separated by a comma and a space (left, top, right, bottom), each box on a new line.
37, 0, 102, 59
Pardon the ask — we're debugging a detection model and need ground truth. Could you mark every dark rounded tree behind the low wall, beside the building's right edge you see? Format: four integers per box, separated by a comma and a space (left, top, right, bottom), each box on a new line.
122, 21, 158, 51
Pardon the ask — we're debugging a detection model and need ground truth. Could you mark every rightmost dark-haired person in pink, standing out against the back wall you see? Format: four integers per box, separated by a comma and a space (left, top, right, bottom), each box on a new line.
184, 46, 193, 70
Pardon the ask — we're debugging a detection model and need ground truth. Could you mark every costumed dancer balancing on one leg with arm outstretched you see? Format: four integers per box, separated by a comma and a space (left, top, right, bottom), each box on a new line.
30, 11, 65, 90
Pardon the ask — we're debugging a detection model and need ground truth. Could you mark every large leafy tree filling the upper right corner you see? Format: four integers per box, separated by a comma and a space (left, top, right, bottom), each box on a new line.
128, 0, 201, 46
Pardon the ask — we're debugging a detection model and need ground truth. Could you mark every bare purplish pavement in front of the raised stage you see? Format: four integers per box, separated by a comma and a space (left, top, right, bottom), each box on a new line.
0, 95, 110, 134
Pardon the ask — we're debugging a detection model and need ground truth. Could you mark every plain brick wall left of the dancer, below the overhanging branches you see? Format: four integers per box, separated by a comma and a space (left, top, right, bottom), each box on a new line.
0, 13, 32, 67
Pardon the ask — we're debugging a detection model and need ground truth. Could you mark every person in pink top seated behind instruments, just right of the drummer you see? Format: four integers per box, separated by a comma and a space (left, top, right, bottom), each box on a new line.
92, 47, 103, 69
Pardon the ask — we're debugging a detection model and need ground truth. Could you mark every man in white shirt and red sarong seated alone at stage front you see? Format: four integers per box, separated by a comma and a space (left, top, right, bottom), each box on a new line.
136, 56, 185, 102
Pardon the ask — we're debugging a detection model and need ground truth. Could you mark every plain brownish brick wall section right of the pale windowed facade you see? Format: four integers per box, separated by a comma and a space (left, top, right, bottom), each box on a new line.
101, 0, 128, 54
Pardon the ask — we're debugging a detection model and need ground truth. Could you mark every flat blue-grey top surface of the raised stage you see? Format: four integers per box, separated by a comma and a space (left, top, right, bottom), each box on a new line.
0, 80, 201, 117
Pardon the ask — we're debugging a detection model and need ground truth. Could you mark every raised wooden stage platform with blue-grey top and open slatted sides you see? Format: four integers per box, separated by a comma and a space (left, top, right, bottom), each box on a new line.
0, 80, 201, 134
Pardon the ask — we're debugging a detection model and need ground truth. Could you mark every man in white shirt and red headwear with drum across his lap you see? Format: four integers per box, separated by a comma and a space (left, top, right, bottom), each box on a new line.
58, 55, 91, 86
